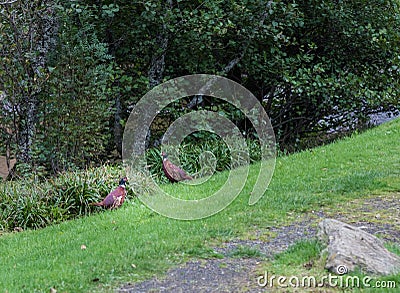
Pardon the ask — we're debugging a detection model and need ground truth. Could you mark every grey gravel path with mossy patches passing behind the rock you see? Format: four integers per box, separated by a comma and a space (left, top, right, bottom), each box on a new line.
117, 193, 400, 293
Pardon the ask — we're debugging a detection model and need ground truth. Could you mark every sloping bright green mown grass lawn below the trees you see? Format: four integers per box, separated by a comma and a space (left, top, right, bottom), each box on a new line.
0, 119, 400, 292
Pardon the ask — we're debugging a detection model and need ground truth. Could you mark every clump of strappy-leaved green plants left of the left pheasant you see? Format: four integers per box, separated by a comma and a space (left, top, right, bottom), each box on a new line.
0, 167, 127, 231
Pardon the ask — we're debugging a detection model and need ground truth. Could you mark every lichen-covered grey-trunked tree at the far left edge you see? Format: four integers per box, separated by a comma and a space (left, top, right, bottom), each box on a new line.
0, 0, 57, 169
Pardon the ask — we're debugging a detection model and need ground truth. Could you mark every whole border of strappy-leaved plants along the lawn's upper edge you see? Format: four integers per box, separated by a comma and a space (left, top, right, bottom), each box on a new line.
0, 139, 261, 231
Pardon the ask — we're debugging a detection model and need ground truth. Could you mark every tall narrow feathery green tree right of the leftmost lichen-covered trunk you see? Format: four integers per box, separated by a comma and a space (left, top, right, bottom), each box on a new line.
36, 4, 114, 172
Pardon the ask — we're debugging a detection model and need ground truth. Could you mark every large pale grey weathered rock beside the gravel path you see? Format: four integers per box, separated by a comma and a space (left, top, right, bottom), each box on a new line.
318, 219, 400, 275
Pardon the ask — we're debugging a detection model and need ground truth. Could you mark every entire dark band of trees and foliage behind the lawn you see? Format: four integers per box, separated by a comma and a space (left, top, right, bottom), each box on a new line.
0, 0, 400, 175
